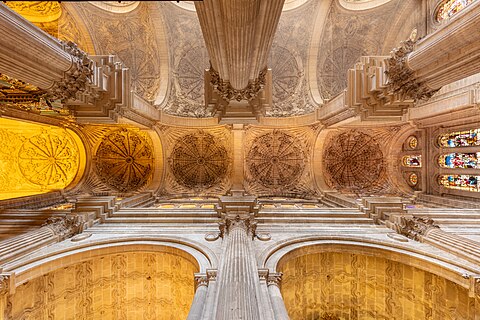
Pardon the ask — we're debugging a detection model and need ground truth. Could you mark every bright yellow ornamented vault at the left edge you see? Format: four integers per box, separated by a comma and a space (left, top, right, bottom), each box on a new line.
0, 118, 86, 200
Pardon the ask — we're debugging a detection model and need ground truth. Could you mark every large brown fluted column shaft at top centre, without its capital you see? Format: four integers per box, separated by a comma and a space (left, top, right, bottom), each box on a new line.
195, 0, 284, 90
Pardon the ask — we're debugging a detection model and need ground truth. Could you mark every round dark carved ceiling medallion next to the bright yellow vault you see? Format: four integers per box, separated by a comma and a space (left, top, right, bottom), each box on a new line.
95, 129, 153, 193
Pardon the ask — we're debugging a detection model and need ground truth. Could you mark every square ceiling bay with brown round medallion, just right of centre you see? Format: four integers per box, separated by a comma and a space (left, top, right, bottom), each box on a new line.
244, 125, 318, 197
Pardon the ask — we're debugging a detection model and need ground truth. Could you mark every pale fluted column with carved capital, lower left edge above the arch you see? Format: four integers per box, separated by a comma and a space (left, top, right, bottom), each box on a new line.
0, 216, 81, 270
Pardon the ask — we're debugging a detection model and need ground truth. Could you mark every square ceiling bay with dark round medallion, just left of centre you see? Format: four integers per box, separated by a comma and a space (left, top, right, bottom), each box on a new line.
160, 126, 233, 197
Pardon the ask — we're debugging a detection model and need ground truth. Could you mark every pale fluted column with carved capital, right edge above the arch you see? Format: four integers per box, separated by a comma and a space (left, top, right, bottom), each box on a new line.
397, 217, 480, 264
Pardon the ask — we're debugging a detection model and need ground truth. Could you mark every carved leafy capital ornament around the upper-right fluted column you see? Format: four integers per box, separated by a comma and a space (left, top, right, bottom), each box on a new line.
385, 30, 439, 101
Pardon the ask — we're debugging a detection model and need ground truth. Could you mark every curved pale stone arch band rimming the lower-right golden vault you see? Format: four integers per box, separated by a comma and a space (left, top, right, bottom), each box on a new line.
259, 236, 479, 289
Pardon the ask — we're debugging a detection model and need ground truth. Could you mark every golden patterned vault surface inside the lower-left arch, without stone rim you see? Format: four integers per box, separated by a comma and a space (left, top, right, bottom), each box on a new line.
6, 251, 198, 320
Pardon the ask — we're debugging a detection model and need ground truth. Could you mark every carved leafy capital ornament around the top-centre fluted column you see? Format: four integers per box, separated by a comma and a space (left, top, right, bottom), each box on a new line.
209, 65, 267, 101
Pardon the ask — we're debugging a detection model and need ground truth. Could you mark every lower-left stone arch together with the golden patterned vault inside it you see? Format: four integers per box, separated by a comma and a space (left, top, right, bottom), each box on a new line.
7, 239, 209, 319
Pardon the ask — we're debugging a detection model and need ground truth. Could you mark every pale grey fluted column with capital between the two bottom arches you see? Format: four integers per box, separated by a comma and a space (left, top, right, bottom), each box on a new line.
215, 215, 261, 320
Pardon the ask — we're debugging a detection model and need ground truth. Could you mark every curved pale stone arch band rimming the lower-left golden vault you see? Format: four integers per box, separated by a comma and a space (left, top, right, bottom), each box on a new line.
3, 237, 218, 287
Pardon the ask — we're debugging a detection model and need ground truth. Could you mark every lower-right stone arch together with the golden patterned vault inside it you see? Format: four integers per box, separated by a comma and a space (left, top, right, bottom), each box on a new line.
261, 234, 478, 319
